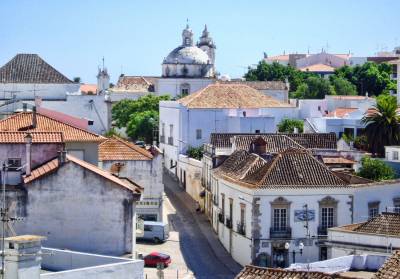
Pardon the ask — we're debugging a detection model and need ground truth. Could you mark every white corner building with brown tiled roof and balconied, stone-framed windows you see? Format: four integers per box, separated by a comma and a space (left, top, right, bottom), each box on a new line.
211, 144, 400, 267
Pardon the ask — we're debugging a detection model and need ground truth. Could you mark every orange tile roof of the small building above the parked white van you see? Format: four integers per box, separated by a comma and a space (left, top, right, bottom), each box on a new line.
99, 136, 153, 161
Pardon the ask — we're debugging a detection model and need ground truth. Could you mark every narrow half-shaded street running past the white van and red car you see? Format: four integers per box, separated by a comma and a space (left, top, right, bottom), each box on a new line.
137, 175, 241, 279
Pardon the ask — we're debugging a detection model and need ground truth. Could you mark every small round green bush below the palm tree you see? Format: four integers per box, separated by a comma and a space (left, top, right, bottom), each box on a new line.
357, 157, 395, 181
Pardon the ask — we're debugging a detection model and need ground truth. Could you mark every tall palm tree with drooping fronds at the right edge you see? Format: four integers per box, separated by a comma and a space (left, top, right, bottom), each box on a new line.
362, 95, 400, 157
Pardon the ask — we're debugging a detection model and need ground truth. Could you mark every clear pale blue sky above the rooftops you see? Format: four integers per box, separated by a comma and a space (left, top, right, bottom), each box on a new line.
0, 0, 400, 82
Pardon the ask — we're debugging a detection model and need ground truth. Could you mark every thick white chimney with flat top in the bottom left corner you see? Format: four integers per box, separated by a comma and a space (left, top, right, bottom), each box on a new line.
4, 235, 44, 279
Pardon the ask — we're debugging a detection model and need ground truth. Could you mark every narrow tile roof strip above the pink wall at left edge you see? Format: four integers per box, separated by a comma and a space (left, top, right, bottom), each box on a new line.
0, 131, 64, 143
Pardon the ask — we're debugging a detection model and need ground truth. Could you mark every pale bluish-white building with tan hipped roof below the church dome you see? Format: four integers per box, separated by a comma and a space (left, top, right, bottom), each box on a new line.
159, 84, 296, 175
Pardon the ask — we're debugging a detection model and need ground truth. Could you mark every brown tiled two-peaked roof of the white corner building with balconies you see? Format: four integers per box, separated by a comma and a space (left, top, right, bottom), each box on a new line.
214, 148, 348, 188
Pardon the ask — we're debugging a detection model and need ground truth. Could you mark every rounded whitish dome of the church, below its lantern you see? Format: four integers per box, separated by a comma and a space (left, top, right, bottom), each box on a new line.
164, 46, 210, 64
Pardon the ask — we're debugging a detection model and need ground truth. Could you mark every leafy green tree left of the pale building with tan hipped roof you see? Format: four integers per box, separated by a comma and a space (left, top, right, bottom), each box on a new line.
112, 94, 170, 143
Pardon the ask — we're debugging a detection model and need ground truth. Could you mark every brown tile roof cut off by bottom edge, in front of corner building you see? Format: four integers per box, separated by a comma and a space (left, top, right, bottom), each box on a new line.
235, 265, 348, 279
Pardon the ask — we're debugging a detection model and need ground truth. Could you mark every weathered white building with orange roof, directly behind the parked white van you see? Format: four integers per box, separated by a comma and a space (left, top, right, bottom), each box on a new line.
99, 136, 164, 221
